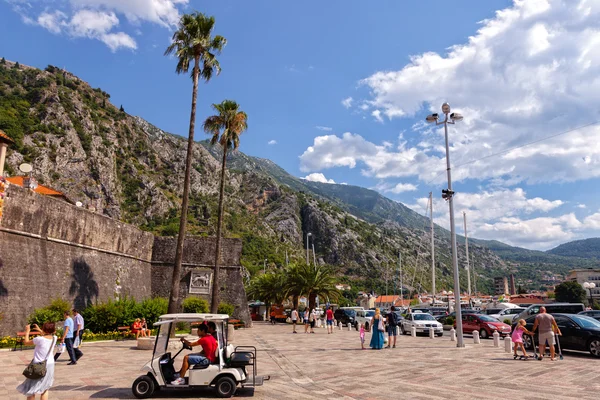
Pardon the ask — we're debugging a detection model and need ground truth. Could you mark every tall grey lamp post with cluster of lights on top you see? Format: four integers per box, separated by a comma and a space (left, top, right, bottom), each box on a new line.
425, 103, 465, 347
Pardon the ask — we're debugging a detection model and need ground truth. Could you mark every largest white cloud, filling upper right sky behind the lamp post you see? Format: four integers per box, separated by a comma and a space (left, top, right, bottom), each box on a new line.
350, 0, 600, 184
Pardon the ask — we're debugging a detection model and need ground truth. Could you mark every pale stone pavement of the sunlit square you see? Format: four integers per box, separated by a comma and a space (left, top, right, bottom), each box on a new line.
0, 323, 600, 400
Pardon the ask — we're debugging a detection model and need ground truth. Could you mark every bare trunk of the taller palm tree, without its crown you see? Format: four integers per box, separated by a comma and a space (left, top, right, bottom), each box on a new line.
168, 56, 200, 314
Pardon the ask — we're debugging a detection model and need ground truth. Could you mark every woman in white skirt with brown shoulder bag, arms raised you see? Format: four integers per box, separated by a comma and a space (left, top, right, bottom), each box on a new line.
17, 322, 56, 400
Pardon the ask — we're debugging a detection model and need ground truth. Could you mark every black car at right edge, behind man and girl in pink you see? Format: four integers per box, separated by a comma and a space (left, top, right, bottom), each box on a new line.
523, 314, 600, 357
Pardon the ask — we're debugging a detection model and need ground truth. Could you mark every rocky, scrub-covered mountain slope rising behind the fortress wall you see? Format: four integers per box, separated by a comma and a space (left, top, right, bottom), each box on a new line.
0, 61, 548, 296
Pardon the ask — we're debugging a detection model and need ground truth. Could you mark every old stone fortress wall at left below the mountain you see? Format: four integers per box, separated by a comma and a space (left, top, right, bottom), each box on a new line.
0, 185, 249, 336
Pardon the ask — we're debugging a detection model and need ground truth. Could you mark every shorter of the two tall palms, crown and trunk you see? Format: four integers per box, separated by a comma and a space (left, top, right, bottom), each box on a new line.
204, 100, 248, 313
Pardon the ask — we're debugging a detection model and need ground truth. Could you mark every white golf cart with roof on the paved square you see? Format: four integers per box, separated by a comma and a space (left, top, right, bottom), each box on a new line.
131, 313, 269, 399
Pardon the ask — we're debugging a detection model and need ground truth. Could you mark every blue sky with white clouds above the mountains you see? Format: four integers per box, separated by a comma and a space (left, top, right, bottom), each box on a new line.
0, 0, 600, 250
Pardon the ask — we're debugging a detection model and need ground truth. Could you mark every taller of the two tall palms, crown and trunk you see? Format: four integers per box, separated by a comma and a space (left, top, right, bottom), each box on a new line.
165, 12, 227, 313
